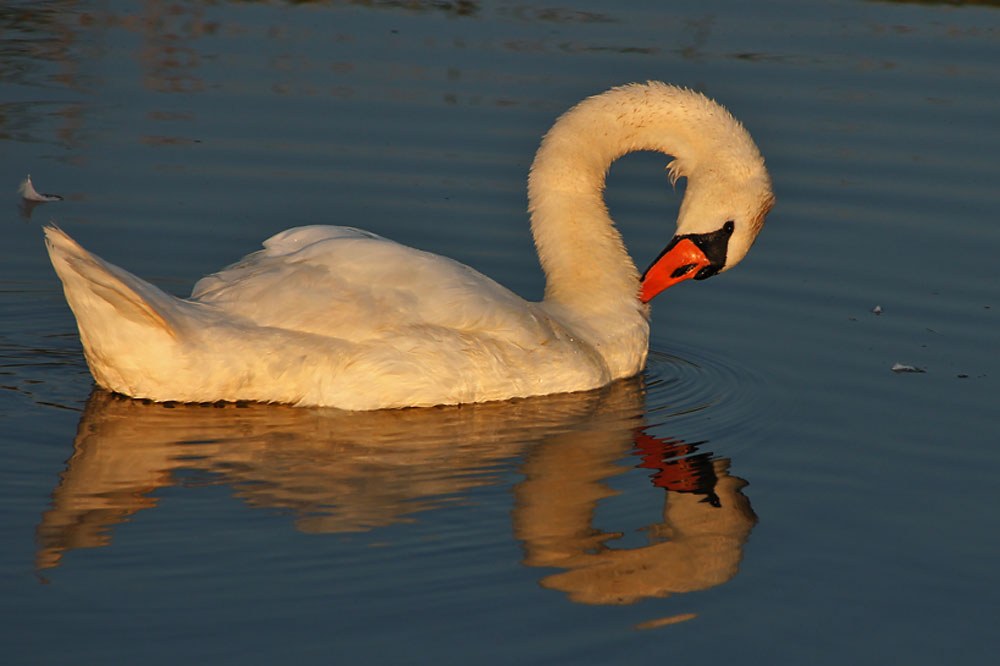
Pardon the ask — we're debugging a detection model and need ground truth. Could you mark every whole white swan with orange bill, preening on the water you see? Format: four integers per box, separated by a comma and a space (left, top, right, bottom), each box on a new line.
45, 81, 774, 410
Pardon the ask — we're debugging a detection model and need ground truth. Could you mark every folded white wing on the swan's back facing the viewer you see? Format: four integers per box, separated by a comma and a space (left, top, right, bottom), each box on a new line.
191, 226, 558, 346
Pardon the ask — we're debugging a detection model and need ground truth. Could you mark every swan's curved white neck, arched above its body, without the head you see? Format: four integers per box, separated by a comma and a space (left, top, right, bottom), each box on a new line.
528, 83, 756, 314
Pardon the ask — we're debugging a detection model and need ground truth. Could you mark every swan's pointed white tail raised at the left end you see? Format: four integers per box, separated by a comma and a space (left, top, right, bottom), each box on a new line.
45, 225, 179, 338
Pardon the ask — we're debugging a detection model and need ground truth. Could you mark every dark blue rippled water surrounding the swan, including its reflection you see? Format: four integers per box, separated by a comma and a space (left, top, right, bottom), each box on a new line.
0, 1, 1000, 664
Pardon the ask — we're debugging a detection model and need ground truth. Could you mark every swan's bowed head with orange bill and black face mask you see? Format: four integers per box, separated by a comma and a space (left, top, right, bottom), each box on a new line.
639, 157, 774, 303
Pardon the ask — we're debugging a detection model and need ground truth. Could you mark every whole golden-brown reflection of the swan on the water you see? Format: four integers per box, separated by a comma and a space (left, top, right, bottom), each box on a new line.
36, 380, 756, 604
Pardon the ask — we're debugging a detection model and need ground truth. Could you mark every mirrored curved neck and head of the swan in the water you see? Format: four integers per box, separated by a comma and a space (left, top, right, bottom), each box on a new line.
514, 429, 757, 604
